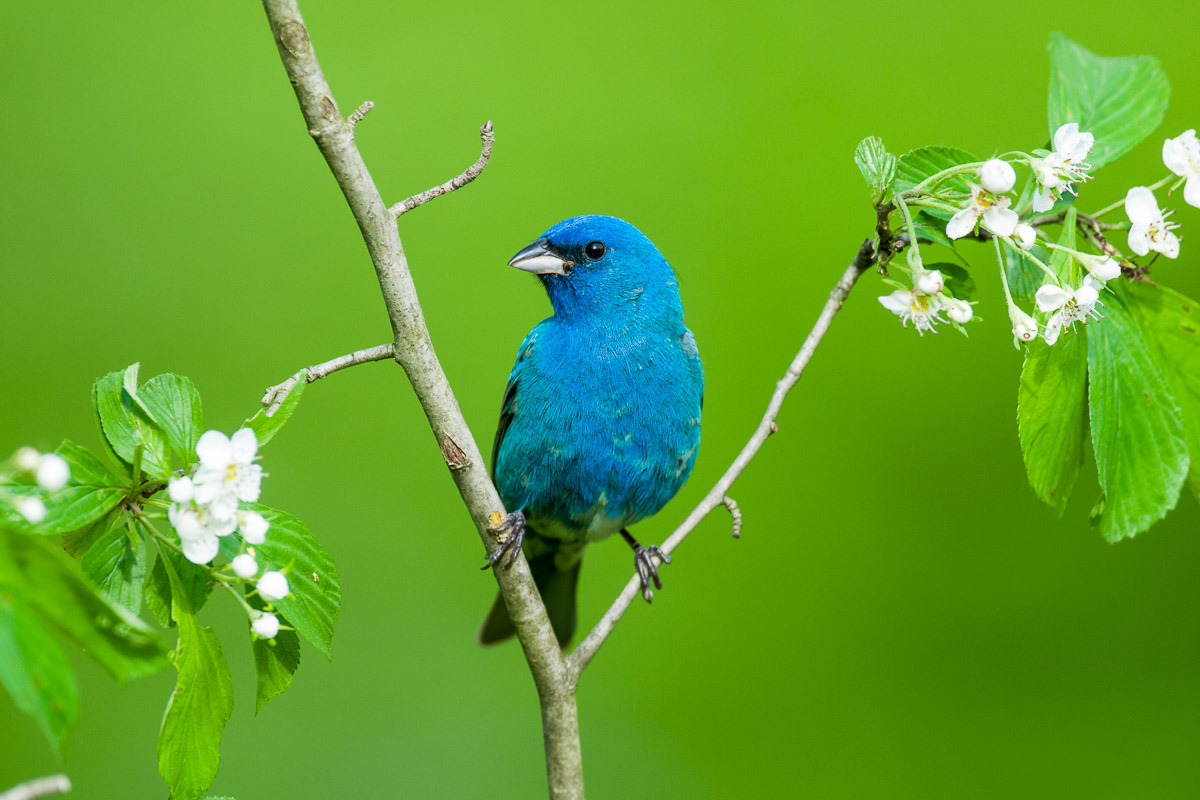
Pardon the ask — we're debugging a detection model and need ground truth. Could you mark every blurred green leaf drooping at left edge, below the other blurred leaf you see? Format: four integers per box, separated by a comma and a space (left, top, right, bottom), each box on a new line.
0, 591, 79, 752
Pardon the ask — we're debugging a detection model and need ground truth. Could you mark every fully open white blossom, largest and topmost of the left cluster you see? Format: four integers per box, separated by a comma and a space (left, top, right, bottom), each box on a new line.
193, 428, 263, 522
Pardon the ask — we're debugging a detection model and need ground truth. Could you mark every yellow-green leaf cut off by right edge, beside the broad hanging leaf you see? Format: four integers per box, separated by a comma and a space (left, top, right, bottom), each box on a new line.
1126, 281, 1200, 500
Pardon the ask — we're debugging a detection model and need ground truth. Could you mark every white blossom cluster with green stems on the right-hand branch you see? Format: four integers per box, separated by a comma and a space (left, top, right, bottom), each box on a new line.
880, 122, 1200, 347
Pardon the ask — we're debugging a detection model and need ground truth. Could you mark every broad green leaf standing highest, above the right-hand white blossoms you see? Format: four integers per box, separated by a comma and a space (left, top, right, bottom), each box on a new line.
1048, 34, 1171, 167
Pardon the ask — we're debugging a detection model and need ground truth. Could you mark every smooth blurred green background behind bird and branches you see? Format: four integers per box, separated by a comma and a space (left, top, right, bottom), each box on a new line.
0, 0, 1200, 800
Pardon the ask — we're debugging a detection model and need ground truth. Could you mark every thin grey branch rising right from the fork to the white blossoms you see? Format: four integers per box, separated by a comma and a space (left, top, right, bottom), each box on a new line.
566, 239, 876, 686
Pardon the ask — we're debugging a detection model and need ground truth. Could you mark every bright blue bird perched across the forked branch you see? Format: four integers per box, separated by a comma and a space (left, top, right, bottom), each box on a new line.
479, 216, 704, 644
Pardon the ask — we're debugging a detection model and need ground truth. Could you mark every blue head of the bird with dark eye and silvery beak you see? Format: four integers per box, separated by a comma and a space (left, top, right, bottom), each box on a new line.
509, 215, 683, 324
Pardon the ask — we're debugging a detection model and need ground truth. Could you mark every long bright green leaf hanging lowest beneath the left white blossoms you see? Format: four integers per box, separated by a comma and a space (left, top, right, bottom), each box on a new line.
158, 554, 233, 800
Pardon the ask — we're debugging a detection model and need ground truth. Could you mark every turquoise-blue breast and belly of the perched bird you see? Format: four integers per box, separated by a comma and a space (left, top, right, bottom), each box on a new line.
494, 316, 703, 541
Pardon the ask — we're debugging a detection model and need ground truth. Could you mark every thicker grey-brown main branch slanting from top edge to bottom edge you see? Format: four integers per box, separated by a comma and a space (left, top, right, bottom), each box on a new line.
263, 0, 583, 798
